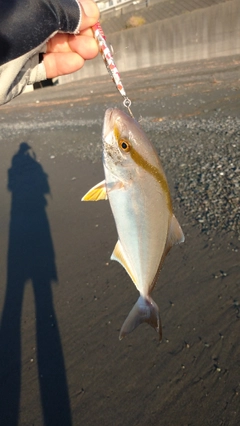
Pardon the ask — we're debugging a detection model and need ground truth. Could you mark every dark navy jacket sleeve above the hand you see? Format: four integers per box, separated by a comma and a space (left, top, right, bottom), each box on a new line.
0, 0, 81, 66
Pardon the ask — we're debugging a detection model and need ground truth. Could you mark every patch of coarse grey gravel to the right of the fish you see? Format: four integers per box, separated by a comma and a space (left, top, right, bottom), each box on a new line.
142, 117, 240, 239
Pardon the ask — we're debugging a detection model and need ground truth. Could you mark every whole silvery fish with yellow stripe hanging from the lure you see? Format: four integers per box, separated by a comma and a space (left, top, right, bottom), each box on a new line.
82, 108, 184, 341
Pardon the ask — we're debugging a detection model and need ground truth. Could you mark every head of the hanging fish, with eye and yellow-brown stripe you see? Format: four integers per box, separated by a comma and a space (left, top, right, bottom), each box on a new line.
103, 108, 159, 179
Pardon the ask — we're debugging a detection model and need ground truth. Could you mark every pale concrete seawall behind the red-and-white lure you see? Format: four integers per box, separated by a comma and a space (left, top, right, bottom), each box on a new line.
60, 0, 240, 83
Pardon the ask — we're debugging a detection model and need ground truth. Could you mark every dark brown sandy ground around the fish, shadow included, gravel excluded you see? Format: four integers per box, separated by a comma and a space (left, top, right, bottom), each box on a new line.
0, 58, 240, 426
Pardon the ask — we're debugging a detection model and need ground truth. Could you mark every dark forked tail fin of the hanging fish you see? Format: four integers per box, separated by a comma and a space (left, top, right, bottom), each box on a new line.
119, 296, 162, 341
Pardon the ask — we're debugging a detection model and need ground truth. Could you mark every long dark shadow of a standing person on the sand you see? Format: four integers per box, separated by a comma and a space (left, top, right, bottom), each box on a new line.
0, 142, 72, 426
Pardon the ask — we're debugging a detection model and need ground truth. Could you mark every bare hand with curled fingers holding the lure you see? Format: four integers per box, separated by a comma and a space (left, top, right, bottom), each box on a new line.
43, 0, 99, 78
